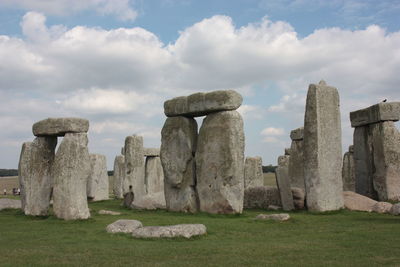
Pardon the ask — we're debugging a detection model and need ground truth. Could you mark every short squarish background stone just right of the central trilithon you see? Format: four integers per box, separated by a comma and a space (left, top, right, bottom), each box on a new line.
244, 157, 264, 189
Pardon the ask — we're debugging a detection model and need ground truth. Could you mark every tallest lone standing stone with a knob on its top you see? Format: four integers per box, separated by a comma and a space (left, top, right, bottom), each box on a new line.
304, 81, 343, 211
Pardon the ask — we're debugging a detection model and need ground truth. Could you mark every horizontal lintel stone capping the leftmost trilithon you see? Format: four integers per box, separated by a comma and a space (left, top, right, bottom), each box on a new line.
32, 118, 89, 136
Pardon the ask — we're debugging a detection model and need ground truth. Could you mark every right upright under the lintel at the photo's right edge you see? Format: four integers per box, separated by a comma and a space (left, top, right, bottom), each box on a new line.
369, 121, 400, 201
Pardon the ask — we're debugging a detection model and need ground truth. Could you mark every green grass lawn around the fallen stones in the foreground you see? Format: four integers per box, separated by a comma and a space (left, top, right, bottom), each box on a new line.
0, 200, 400, 266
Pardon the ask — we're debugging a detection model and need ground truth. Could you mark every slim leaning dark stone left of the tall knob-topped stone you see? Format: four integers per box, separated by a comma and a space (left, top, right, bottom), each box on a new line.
275, 155, 294, 210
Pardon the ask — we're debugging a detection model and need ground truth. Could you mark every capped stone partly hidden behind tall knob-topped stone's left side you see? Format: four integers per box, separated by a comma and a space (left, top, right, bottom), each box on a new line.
289, 127, 305, 190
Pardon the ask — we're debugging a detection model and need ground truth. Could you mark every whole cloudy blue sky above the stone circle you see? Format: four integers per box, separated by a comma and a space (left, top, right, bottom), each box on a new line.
0, 0, 400, 169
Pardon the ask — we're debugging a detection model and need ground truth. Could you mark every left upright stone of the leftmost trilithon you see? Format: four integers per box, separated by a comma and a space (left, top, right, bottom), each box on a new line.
18, 137, 57, 216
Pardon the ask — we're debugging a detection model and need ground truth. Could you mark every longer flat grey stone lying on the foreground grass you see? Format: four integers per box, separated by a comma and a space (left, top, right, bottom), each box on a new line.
132, 224, 207, 238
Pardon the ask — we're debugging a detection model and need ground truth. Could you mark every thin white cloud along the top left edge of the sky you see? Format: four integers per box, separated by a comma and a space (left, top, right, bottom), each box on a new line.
0, 0, 138, 21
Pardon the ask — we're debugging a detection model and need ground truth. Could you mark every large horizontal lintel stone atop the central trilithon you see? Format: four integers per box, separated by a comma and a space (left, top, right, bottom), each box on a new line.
164, 90, 243, 117
